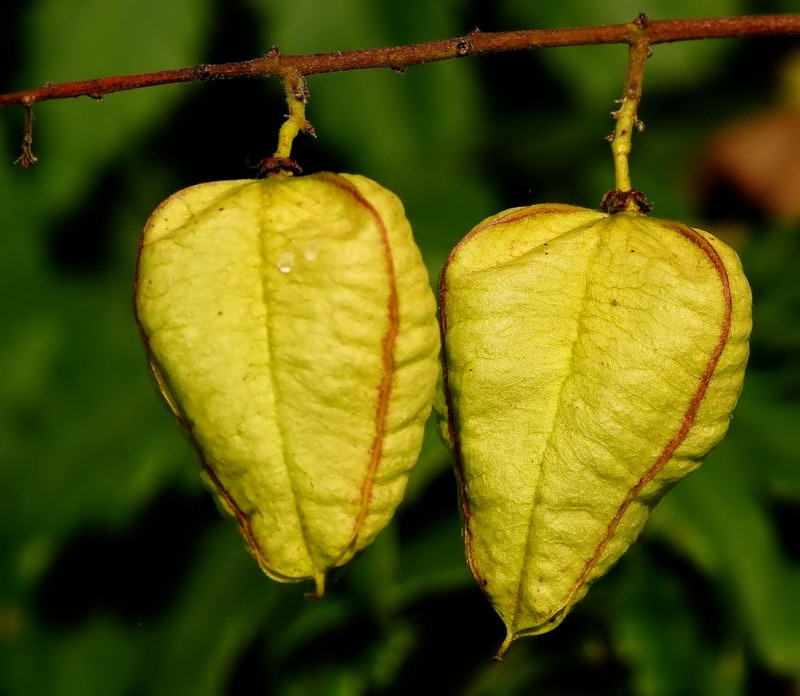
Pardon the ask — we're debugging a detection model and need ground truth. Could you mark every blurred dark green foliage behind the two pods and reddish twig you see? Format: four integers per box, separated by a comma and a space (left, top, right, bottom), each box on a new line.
0, 0, 800, 696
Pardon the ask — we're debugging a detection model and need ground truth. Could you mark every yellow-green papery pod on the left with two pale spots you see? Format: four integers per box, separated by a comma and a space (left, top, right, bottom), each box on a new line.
135, 173, 439, 596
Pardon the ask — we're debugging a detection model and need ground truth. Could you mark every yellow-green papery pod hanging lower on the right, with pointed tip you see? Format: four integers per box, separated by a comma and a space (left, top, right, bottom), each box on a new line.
436, 205, 751, 655
